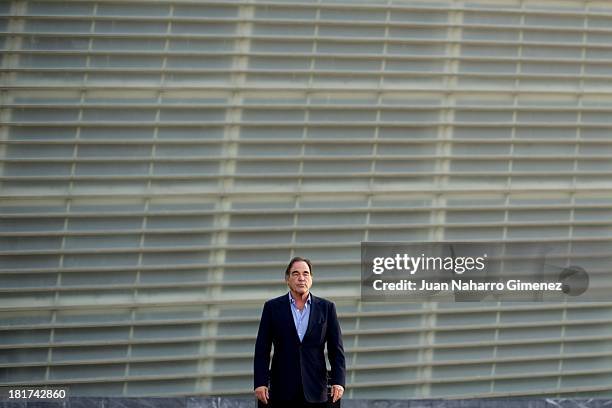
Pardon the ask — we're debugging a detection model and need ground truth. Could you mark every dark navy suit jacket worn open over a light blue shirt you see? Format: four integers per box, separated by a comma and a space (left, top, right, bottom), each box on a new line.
254, 293, 346, 402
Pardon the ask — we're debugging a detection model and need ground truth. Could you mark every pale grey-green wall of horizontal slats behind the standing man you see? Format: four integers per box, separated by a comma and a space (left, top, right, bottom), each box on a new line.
0, 0, 612, 398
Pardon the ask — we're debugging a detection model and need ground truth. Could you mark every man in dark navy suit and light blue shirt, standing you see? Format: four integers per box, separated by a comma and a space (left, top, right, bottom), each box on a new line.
254, 257, 346, 408
